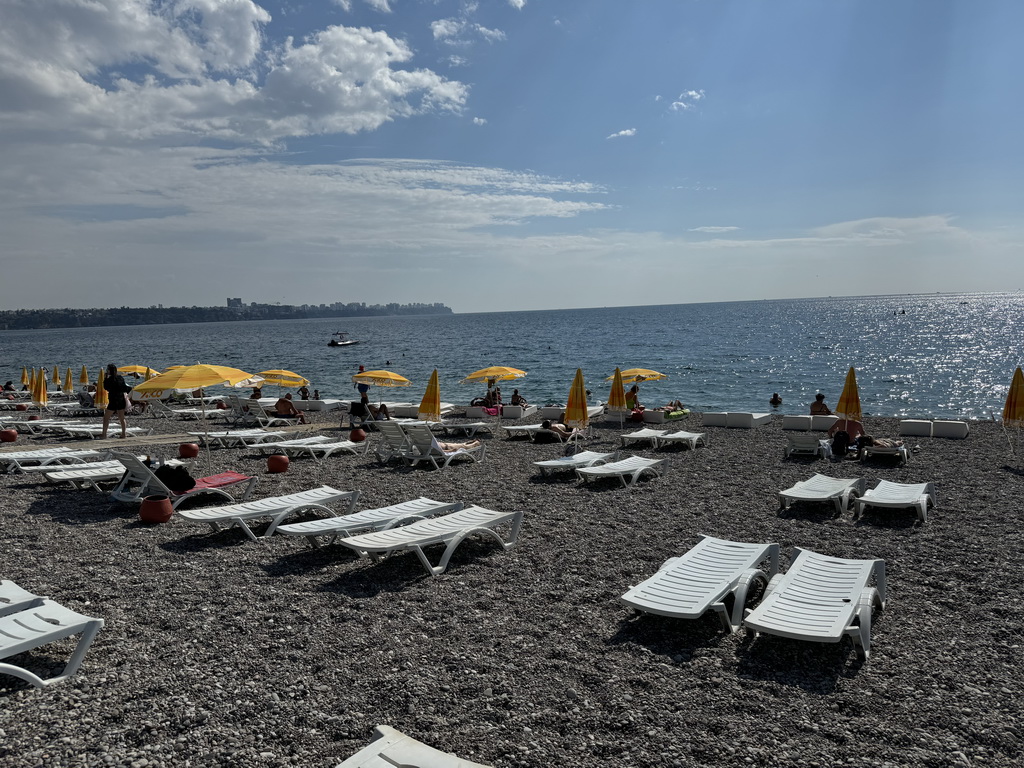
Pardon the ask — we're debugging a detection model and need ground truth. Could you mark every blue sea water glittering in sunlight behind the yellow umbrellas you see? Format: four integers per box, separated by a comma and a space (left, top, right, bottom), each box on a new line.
0, 293, 1024, 418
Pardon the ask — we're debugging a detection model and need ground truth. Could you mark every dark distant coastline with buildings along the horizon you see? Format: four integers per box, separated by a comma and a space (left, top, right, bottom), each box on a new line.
0, 300, 454, 331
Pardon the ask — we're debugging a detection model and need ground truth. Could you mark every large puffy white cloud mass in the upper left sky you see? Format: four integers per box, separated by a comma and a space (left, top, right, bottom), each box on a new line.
0, 0, 468, 142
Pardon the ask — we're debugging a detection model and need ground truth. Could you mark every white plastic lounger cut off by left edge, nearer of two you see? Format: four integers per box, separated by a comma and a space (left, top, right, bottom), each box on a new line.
0, 593, 103, 688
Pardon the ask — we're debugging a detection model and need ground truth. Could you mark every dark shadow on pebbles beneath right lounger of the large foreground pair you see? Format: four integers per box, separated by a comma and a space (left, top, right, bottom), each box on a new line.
737, 632, 863, 695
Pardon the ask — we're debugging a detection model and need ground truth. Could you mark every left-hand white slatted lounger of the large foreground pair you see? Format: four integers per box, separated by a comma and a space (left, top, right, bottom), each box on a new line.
618, 536, 778, 632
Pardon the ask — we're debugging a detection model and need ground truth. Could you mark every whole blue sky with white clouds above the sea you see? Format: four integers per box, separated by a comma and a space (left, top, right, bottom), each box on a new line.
0, 0, 1024, 312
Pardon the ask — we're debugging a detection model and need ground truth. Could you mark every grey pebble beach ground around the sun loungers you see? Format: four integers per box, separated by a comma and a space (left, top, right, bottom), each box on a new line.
0, 413, 1024, 768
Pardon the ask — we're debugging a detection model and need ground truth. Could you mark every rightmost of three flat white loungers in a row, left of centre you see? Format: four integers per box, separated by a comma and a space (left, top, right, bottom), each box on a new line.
338, 505, 522, 575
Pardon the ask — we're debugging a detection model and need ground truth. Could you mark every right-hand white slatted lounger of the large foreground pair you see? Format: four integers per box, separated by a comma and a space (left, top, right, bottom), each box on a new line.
743, 548, 886, 660
